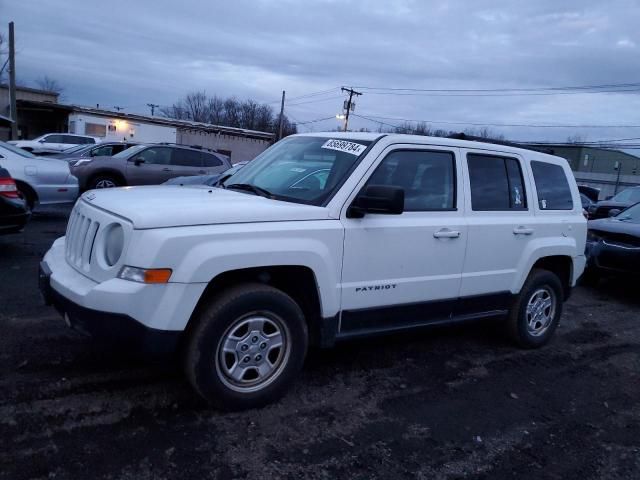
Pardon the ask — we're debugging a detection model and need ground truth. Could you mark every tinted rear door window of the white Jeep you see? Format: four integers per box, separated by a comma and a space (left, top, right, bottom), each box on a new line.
467, 153, 527, 211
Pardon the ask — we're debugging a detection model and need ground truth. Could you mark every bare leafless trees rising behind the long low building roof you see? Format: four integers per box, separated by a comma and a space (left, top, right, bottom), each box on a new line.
160, 91, 298, 137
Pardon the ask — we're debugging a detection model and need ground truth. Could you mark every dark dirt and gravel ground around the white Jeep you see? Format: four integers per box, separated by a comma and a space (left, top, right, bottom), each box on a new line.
0, 209, 640, 479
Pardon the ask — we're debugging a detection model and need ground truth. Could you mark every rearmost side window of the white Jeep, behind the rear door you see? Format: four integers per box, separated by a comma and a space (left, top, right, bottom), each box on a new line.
531, 160, 573, 210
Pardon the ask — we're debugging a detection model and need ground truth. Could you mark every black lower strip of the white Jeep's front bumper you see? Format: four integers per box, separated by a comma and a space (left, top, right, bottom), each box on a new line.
38, 261, 180, 354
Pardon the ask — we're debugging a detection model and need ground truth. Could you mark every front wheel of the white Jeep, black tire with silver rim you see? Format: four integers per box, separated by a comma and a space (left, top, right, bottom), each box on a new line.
184, 283, 308, 410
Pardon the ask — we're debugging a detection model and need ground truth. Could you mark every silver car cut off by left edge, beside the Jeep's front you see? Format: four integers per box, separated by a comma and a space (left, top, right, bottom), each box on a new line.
0, 142, 78, 209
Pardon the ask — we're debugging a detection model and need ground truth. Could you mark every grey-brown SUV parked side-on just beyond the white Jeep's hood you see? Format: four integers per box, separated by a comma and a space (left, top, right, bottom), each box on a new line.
70, 143, 231, 191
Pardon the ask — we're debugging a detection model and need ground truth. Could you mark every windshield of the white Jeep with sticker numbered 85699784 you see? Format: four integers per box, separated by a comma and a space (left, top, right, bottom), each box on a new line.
224, 136, 371, 205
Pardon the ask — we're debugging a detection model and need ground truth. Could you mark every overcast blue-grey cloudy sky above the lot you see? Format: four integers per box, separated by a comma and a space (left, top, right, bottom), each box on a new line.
0, 0, 640, 140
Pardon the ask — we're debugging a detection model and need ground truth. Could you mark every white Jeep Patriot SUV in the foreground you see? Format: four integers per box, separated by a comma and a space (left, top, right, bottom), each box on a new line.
40, 133, 586, 409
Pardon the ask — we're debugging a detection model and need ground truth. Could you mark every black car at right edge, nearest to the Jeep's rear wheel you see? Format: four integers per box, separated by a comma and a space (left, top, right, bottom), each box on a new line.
584, 203, 640, 281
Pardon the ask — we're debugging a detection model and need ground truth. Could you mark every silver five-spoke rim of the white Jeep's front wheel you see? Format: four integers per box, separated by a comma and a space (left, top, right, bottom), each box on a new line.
216, 312, 291, 393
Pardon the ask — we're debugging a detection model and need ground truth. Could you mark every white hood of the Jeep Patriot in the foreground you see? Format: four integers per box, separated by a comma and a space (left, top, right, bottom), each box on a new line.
81, 185, 329, 229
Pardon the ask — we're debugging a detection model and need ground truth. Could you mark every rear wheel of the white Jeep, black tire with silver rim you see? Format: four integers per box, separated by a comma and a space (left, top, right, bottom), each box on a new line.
507, 269, 564, 348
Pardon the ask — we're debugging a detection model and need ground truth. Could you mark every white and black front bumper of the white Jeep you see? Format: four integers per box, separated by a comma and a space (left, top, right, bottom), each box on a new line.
39, 237, 206, 352
